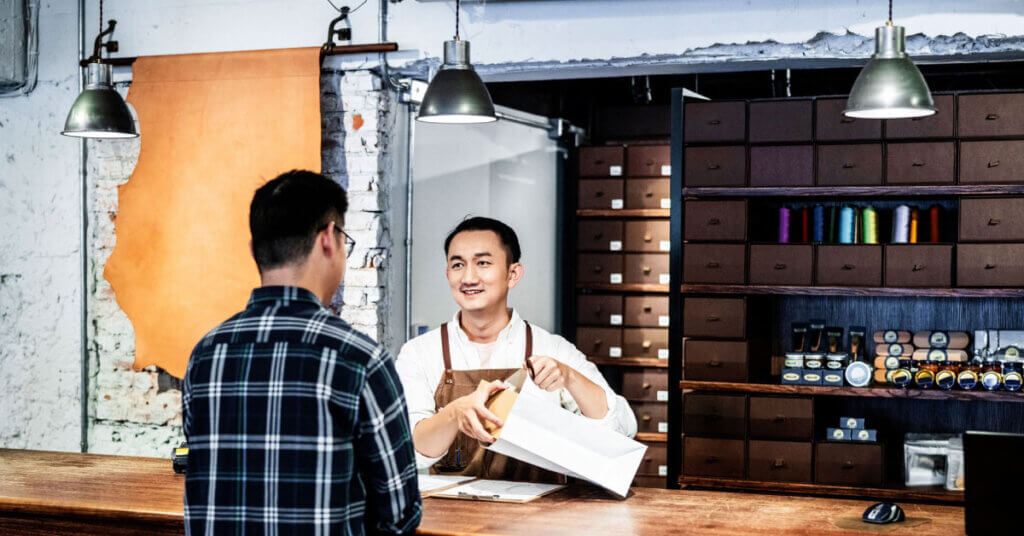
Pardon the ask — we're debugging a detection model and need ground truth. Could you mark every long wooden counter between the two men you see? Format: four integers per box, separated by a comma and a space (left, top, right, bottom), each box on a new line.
0, 450, 964, 536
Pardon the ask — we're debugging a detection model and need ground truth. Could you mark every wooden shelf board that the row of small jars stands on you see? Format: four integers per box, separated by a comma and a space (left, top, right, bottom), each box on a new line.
679, 379, 1024, 403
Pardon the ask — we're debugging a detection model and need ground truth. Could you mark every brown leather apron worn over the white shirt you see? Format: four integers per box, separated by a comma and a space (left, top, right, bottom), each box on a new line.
430, 323, 565, 484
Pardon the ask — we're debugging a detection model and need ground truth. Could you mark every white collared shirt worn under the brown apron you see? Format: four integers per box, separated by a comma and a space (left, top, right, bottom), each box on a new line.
396, 310, 637, 468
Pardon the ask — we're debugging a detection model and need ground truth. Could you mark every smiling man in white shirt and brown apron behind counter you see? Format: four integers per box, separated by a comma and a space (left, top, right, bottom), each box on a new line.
397, 217, 637, 482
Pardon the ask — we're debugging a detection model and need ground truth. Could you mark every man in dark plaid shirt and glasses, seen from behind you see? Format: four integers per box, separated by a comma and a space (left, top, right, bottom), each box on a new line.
182, 171, 421, 535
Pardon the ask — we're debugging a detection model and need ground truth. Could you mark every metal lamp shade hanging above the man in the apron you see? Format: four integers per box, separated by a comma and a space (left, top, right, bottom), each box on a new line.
416, 40, 498, 124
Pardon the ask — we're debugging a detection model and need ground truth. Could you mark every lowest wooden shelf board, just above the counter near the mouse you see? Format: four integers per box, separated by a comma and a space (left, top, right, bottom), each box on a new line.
679, 475, 964, 504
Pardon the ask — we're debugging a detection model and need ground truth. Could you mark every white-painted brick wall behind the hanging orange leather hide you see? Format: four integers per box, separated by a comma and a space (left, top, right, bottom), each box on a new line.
88, 71, 396, 456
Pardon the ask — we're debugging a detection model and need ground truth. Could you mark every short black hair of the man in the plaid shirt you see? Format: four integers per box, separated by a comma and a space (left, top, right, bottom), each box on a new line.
249, 169, 348, 272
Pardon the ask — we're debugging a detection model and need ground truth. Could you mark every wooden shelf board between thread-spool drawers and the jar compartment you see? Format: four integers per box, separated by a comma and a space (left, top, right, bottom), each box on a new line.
682, 284, 1024, 298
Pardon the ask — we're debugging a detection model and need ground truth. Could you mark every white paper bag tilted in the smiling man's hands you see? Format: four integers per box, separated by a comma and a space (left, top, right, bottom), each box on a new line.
487, 382, 647, 498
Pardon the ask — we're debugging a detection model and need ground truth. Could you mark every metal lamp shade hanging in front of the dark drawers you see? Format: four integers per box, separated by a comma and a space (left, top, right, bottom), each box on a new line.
843, 26, 935, 119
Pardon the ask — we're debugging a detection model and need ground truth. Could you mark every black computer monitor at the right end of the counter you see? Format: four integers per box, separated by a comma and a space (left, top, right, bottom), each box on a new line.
964, 431, 1024, 536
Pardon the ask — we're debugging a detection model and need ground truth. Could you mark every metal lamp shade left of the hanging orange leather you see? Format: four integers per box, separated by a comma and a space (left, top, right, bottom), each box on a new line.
60, 63, 138, 138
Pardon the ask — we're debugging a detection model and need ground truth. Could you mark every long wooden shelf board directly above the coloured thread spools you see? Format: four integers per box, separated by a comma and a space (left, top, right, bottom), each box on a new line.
683, 184, 1024, 198
